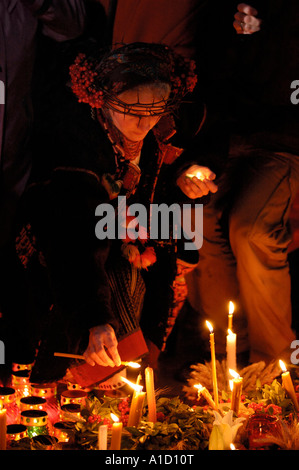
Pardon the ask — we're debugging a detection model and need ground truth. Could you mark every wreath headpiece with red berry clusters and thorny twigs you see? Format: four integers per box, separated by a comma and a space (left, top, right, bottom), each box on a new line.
70, 43, 197, 115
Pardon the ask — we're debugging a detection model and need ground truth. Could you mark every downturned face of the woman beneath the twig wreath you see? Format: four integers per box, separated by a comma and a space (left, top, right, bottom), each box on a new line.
109, 86, 170, 142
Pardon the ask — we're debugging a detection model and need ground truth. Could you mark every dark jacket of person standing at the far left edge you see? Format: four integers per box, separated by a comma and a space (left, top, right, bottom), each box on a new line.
0, 0, 85, 247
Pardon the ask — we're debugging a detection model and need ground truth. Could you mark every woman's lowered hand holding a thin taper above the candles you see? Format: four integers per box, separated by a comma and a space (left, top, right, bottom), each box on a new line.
83, 324, 121, 367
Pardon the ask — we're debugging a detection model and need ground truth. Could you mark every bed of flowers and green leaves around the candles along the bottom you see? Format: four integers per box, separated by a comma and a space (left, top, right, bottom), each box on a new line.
6, 362, 299, 451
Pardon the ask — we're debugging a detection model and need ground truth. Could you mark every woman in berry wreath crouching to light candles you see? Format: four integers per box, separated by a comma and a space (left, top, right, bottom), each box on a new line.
12, 43, 217, 381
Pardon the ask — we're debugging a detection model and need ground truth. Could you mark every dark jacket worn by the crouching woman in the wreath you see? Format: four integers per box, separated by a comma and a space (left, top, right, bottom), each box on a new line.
17, 91, 211, 380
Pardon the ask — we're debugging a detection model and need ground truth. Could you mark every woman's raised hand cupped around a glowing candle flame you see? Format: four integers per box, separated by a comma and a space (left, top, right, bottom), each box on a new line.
177, 165, 218, 199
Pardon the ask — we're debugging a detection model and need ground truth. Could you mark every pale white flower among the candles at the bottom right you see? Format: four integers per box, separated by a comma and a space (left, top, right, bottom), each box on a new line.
209, 410, 245, 450
